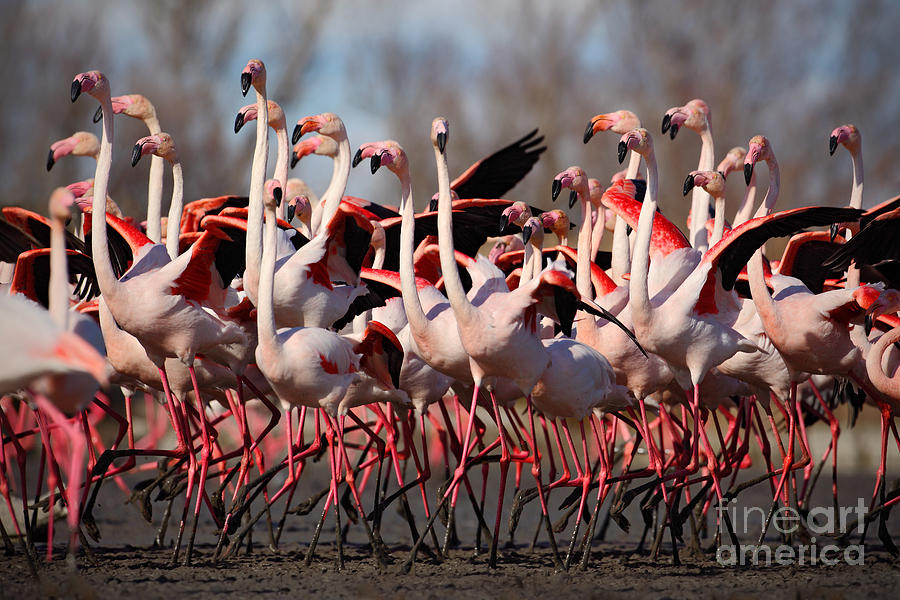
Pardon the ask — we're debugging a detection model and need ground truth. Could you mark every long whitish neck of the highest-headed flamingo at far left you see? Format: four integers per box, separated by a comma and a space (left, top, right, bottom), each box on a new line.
91, 92, 119, 298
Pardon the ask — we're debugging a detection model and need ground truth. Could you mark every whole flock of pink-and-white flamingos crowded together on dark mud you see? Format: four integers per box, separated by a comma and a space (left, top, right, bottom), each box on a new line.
0, 60, 900, 570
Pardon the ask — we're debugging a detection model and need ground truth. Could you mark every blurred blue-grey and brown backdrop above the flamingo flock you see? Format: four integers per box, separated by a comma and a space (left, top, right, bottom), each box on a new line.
0, 0, 900, 243
